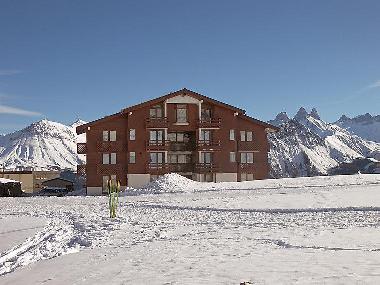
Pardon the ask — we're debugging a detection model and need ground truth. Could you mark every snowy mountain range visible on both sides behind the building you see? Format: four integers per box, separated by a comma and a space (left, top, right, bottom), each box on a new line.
0, 108, 380, 178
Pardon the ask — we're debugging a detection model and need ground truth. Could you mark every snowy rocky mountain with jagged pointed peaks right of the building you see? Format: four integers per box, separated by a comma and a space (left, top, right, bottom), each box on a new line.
269, 108, 380, 178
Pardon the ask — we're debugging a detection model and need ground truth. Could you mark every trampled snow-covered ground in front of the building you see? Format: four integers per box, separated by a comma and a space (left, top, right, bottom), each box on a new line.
0, 175, 380, 285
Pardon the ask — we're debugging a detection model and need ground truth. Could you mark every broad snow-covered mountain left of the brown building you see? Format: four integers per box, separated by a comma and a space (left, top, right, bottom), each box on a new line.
0, 120, 85, 169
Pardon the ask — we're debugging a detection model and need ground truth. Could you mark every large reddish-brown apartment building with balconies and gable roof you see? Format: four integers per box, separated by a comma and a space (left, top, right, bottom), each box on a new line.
77, 89, 277, 195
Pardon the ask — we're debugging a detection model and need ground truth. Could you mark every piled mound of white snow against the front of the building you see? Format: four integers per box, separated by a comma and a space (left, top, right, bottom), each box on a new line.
140, 173, 199, 193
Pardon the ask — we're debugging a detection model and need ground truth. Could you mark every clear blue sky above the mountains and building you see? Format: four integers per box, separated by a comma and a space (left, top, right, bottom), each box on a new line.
0, 0, 380, 133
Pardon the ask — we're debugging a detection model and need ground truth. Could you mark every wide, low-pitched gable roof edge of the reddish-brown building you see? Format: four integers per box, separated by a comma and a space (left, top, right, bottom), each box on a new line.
76, 88, 278, 134
